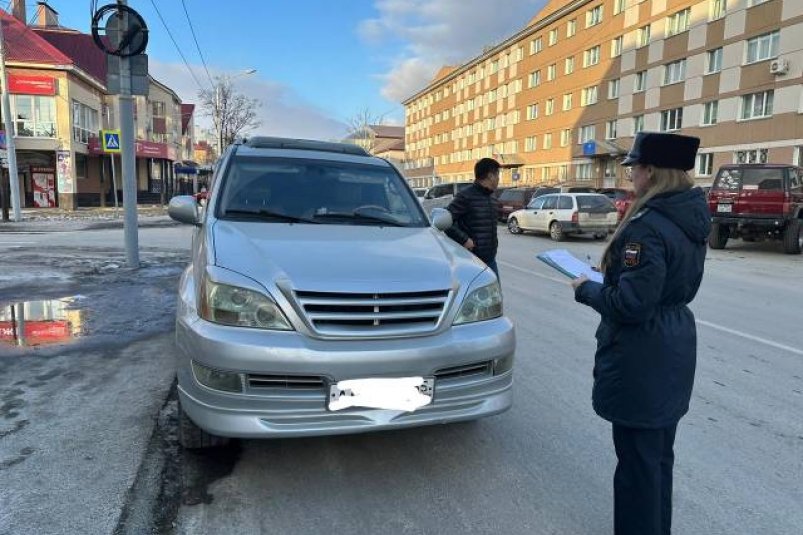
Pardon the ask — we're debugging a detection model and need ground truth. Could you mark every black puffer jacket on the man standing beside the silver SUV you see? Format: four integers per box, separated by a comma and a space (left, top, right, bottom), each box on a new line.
446, 182, 499, 263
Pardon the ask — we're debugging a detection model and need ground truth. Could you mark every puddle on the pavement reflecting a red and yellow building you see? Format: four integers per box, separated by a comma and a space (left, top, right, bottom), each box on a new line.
0, 295, 85, 346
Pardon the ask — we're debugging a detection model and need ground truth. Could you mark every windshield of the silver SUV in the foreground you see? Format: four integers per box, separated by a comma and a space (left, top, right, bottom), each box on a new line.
216, 157, 427, 227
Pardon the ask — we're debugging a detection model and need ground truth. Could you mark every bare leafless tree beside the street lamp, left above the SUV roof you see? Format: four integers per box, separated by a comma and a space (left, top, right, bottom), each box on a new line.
198, 76, 262, 155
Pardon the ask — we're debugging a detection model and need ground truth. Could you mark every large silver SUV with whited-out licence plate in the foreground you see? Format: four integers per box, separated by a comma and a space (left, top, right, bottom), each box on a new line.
169, 138, 515, 448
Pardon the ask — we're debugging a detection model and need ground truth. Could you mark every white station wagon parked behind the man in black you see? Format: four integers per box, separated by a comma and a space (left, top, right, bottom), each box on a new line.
507, 193, 618, 241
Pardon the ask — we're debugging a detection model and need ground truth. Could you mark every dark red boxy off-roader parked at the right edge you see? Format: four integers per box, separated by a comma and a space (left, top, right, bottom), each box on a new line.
708, 164, 803, 254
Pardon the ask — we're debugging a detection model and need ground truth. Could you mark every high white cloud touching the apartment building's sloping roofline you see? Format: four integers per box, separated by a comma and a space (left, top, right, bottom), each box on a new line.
366, 0, 547, 102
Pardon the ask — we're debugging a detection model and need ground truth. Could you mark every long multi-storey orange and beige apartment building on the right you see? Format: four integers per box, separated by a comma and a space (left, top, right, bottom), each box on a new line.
404, 0, 803, 187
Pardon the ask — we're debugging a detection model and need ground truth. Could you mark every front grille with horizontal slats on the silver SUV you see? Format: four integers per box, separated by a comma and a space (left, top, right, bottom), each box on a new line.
295, 290, 450, 337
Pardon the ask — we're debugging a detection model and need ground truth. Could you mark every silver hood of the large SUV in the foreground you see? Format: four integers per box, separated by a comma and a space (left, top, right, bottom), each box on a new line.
212, 221, 485, 292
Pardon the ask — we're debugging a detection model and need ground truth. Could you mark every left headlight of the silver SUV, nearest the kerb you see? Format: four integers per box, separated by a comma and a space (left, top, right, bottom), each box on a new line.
199, 279, 293, 331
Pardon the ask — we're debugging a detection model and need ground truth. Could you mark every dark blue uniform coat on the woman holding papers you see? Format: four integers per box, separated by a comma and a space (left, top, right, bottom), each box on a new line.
575, 188, 710, 428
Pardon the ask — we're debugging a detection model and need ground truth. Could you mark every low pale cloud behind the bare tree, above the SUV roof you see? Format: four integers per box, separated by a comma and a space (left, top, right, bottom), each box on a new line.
149, 59, 346, 140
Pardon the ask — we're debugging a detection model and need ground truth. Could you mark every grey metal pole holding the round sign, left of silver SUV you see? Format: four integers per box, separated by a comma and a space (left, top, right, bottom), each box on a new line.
118, 0, 139, 268
